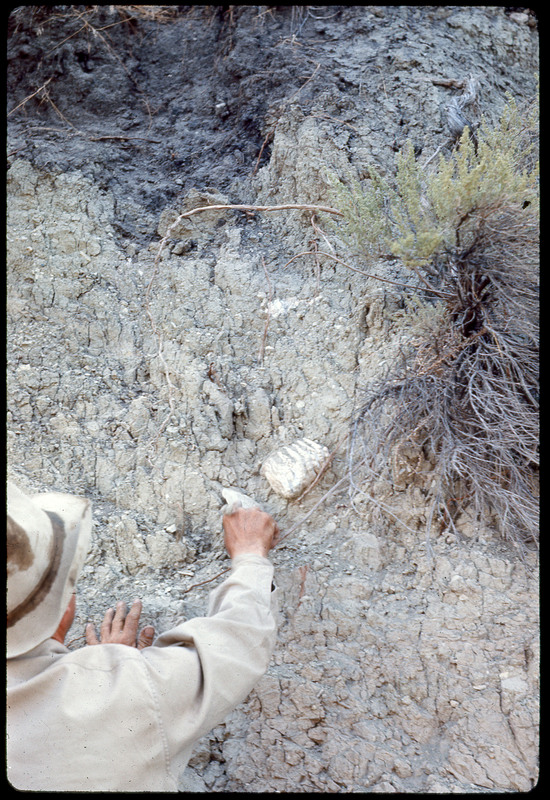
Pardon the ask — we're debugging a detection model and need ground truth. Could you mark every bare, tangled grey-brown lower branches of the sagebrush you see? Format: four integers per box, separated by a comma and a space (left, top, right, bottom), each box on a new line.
352, 198, 539, 548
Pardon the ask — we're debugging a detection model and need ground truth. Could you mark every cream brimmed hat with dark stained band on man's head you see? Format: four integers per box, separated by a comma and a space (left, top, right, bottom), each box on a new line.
6, 482, 92, 658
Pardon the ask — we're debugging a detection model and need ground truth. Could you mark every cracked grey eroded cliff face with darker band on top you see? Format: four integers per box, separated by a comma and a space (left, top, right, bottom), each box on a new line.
7, 6, 539, 792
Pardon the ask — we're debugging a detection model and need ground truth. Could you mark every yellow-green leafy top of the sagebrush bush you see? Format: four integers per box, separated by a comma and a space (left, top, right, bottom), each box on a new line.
336, 87, 539, 268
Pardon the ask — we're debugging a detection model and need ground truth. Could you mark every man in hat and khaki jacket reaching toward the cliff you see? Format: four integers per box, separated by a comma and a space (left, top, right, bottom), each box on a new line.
7, 484, 278, 792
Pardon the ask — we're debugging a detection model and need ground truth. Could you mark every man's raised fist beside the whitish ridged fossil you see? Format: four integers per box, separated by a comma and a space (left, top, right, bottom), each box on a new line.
223, 508, 279, 558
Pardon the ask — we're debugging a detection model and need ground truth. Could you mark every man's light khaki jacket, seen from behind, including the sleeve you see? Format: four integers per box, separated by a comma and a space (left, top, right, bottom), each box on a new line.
7, 555, 277, 792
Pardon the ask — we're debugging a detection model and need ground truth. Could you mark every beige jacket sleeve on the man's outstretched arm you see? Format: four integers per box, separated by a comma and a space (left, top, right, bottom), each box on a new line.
136, 555, 277, 759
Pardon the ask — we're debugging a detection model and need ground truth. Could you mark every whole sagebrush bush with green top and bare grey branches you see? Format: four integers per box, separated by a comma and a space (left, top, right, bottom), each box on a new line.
336, 89, 539, 545
